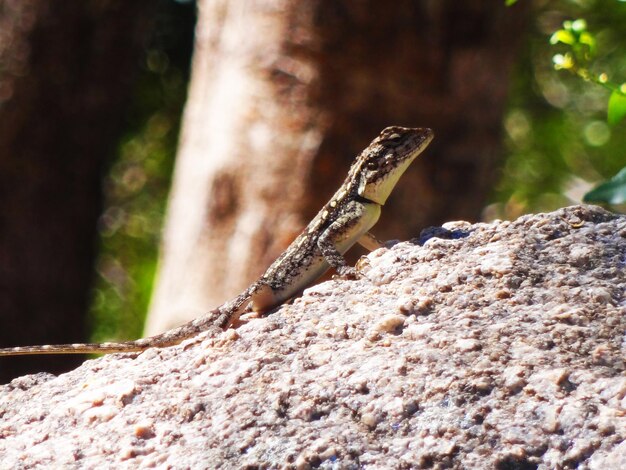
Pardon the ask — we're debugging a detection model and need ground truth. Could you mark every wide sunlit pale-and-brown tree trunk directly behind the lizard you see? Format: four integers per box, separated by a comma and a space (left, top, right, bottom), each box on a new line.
147, 0, 526, 333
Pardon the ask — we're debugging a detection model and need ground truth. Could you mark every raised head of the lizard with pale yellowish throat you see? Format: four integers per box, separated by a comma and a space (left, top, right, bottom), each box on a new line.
353, 126, 434, 206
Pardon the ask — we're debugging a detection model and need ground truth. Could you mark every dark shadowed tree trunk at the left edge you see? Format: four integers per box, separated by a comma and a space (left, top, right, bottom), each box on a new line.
0, 0, 152, 381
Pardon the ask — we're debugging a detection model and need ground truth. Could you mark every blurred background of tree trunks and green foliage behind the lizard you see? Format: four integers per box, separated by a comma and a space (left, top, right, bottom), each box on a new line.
0, 0, 626, 382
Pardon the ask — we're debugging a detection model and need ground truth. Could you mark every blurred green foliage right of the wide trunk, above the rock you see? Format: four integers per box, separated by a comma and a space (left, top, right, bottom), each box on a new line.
491, 0, 626, 218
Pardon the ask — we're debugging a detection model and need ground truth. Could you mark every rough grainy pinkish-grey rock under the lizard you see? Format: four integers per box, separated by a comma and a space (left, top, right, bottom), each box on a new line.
0, 207, 626, 470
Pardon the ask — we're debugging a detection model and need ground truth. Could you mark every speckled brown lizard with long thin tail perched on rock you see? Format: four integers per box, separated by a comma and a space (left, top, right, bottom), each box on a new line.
0, 126, 434, 356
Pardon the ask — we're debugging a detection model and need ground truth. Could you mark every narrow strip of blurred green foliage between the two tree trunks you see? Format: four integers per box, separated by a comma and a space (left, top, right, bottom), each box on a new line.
90, 0, 195, 341
